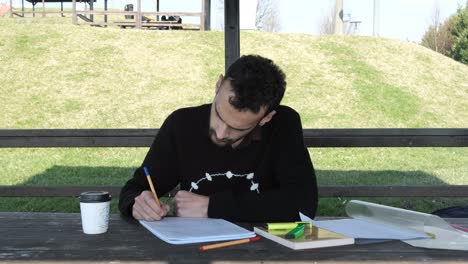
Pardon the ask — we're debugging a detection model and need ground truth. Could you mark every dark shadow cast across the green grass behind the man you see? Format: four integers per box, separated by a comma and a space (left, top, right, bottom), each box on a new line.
0, 166, 460, 216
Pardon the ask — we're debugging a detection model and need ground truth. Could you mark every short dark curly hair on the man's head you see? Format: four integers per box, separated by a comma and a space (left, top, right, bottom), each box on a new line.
223, 55, 286, 113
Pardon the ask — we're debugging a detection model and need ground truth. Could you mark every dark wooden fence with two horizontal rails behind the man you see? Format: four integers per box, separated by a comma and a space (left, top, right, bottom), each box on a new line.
0, 128, 468, 197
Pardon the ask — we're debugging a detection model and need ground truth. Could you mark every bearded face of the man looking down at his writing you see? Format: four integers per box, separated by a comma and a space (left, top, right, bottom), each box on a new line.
209, 80, 269, 148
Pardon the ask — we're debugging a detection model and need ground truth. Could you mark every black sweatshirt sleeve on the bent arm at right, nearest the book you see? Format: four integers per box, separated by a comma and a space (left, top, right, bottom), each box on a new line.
208, 111, 318, 222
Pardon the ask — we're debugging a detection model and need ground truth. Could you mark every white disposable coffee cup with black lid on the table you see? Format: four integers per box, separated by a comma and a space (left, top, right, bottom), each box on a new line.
80, 191, 111, 235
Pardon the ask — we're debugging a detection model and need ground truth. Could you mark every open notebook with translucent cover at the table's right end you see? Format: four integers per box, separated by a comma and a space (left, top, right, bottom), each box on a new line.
301, 200, 468, 250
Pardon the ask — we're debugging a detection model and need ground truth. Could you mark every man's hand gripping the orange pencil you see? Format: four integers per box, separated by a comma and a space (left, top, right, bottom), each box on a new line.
132, 191, 169, 221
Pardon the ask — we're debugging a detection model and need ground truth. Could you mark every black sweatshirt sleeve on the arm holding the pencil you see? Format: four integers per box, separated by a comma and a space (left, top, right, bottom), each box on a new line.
119, 113, 179, 217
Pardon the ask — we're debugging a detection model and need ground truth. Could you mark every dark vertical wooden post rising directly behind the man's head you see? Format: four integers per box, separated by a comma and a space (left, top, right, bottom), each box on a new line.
224, 0, 240, 71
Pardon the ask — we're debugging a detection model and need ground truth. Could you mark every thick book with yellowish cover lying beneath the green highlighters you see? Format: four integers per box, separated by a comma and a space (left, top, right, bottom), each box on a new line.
254, 226, 354, 250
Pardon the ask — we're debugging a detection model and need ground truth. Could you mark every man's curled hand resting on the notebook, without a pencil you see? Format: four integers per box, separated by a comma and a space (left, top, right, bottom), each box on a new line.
174, 191, 210, 217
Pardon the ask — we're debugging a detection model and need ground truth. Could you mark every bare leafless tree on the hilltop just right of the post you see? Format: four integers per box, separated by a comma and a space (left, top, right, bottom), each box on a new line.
255, 0, 281, 32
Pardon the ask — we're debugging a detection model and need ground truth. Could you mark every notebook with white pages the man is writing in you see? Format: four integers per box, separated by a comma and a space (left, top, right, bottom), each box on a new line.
140, 217, 255, 244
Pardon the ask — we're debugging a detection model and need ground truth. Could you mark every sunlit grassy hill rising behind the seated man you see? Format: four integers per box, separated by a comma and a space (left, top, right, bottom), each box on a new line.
0, 18, 468, 213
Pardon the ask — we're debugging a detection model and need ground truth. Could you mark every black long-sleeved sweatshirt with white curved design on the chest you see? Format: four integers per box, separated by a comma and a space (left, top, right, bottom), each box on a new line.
119, 104, 318, 222
